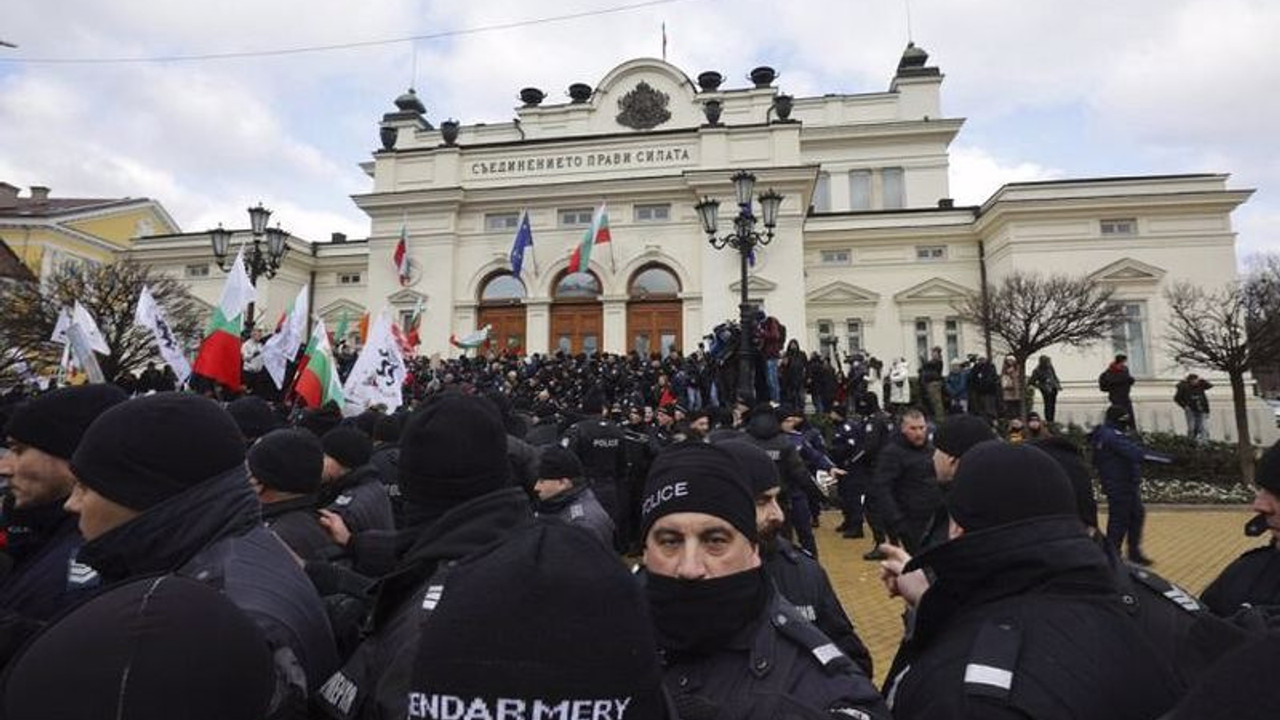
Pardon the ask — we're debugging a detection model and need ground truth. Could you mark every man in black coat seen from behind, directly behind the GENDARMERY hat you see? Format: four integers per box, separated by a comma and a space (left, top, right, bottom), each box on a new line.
317, 392, 534, 720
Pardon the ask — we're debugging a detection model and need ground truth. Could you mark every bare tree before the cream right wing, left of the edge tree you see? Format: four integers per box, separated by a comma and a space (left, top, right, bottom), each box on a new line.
955, 272, 1124, 414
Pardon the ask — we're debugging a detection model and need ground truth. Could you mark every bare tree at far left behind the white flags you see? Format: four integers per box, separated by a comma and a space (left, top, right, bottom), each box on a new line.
0, 261, 205, 379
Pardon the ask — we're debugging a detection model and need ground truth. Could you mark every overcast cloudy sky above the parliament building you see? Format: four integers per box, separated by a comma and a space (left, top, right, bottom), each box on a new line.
0, 0, 1280, 259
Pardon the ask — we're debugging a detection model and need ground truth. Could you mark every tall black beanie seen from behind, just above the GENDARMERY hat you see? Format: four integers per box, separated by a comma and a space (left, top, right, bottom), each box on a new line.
399, 392, 511, 516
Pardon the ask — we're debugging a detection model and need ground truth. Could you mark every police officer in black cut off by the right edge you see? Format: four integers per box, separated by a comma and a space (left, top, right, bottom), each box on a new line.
1201, 442, 1280, 616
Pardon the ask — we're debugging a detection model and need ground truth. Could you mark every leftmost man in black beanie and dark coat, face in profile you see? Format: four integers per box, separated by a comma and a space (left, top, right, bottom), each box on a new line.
0, 384, 124, 666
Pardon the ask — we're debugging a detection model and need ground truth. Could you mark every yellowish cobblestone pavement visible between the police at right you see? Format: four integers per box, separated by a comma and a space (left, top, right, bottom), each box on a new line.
817, 506, 1266, 685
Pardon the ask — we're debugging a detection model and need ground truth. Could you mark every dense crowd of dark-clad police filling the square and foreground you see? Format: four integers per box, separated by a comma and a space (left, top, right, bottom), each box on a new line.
0, 357, 1280, 720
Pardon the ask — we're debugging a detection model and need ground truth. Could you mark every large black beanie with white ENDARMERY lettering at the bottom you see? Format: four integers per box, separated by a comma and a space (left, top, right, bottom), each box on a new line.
408, 519, 666, 720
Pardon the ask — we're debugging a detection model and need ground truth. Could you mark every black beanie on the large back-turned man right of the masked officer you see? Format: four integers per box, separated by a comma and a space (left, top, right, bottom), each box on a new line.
947, 441, 1078, 532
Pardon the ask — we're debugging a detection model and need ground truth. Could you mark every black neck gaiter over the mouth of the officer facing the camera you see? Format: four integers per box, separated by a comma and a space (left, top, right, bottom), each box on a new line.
645, 566, 769, 653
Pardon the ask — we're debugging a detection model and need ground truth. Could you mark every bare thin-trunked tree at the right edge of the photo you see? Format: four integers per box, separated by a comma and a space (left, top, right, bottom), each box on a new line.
1165, 261, 1280, 480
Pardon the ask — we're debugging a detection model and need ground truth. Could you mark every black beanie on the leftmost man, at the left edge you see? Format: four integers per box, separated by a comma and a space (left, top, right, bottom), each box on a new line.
4, 384, 128, 460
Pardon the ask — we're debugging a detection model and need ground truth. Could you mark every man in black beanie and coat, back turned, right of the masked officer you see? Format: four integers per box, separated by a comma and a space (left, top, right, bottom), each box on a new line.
886, 441, 1181, 720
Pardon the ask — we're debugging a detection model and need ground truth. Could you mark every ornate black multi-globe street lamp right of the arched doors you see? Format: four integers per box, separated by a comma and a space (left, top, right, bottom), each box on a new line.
694, 170, 782, 397
